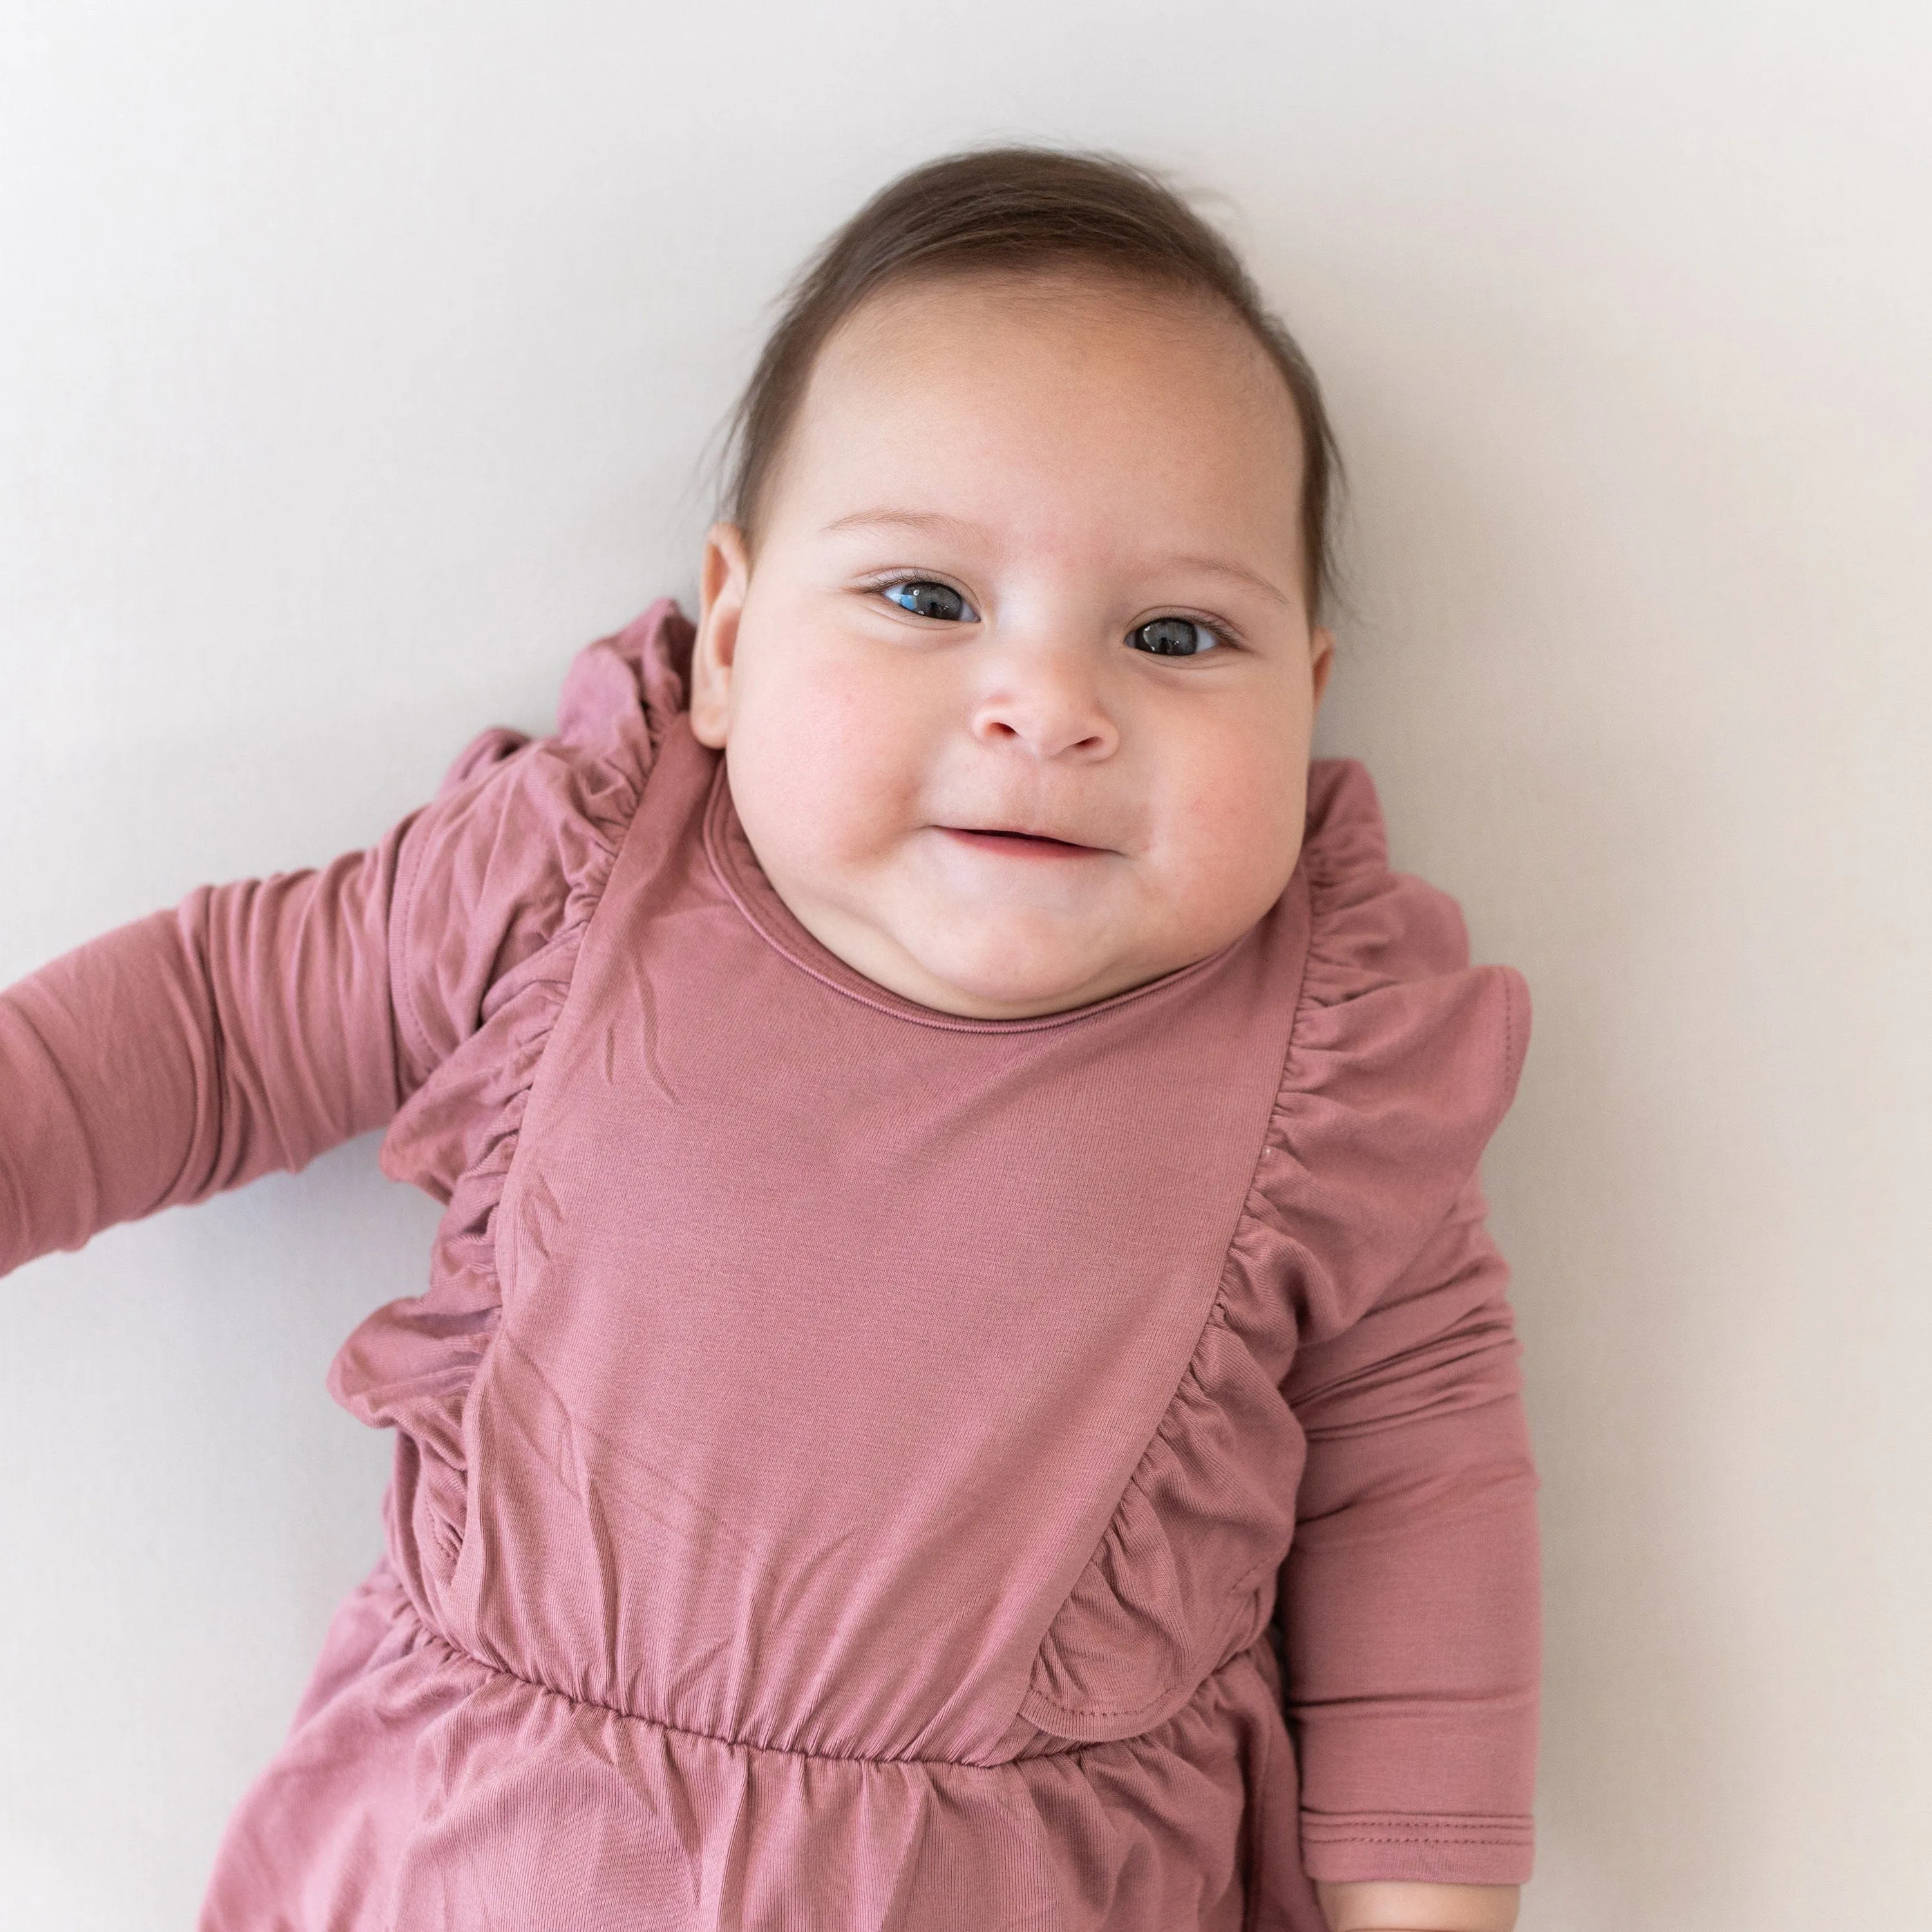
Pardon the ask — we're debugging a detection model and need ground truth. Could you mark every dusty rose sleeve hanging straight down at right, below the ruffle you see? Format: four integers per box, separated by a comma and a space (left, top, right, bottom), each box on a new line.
1283, 1180, 1540, 1884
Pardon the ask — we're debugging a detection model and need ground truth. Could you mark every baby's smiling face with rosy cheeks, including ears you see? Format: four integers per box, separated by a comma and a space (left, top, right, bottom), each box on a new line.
692, 276, 1331, 1018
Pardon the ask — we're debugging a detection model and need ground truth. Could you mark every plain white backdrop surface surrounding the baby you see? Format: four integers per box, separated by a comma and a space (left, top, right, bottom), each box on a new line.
0, 0, 1932, 1932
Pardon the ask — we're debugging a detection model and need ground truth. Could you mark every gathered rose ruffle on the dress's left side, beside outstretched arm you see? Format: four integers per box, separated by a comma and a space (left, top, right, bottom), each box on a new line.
328, 599, 694, 1625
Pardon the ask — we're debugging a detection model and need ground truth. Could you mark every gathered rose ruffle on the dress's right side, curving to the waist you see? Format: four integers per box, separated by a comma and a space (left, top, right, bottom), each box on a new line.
1020, 759, 1528, 1739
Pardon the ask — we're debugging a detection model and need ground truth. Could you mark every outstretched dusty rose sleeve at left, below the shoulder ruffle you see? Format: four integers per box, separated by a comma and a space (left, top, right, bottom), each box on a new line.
0, 838, 410, 1275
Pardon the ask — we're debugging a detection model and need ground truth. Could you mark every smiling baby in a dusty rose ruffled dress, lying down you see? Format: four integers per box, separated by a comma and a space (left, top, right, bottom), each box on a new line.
0, 149, 1538, 1932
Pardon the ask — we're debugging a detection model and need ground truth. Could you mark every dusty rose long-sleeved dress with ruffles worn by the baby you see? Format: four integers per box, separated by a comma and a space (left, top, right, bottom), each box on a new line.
0, 603, 1538, 1932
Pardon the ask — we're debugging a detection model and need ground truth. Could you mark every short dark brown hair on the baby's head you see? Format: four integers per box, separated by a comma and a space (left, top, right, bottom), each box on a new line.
726, 147, 1341, 616
